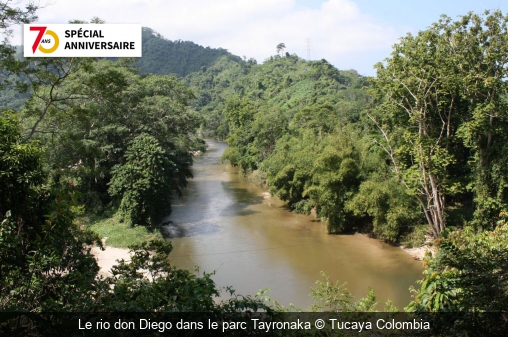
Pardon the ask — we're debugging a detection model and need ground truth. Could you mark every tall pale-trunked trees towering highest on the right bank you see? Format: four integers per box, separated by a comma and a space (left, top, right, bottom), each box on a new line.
368, 12, 508, 237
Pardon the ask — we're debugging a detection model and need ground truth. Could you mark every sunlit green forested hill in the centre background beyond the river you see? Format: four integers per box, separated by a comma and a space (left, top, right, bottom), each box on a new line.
184, 55, 367, 139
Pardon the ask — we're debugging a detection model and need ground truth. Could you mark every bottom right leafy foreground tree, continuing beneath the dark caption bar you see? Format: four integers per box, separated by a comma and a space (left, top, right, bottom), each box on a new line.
405, 218, 508, 336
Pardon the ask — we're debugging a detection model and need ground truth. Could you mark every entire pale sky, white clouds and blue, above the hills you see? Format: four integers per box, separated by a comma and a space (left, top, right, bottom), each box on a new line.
12, 0, 508, 75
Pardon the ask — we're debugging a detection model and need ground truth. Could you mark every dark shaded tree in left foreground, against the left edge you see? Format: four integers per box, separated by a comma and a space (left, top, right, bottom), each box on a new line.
0, 112, 105, 310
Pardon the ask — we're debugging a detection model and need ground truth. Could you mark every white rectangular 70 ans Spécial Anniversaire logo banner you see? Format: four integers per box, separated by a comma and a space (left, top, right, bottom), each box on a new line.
23, 24, 141, 57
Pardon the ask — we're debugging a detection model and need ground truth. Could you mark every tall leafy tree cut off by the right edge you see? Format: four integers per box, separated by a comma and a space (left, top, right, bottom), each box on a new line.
452, 11, 508, 229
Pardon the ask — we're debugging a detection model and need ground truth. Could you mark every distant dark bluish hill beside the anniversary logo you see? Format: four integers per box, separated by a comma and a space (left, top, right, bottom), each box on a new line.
135, 27, 241, 77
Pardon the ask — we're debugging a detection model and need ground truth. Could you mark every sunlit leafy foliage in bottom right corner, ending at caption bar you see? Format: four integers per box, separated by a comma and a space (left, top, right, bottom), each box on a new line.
407, 219, 508, 312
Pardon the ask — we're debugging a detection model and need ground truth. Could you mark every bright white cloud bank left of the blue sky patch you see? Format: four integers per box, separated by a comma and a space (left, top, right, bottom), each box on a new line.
12, 0, 400, 70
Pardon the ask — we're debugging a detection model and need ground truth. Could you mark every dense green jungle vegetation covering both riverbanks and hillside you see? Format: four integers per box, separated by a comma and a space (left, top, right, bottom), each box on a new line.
0, 1, 508, 331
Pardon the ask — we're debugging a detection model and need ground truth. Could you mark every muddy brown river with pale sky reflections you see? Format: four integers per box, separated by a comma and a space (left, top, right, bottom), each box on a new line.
165, 140, 423, 309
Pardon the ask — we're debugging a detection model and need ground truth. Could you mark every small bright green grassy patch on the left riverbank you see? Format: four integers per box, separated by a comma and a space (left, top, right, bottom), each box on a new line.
80, 215, 162, 248
